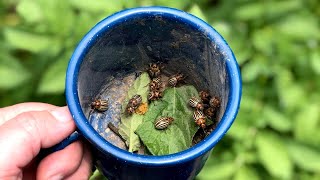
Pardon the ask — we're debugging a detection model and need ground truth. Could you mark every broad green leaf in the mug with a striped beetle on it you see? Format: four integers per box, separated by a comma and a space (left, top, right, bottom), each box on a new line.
136, 86, 199, 155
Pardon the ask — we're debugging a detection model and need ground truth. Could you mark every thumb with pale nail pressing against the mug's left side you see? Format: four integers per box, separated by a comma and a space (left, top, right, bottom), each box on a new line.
0, 107, 75, 174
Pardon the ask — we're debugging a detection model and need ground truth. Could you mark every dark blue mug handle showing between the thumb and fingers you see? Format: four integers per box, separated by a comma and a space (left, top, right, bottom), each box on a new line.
39, 131, 81, 159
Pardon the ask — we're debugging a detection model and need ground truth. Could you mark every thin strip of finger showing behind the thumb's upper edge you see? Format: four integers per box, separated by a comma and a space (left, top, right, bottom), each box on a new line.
0, 102, 57, 126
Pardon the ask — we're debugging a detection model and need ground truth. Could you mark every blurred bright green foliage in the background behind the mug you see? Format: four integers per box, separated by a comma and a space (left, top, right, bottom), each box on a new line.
0, 0, 320, 180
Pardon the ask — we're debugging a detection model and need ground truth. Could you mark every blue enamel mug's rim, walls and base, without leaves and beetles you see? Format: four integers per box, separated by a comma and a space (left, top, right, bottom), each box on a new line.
66, 7, 241, 179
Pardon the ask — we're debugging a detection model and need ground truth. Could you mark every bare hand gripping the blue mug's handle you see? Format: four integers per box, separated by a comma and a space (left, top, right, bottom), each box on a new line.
0, 103, 92, 180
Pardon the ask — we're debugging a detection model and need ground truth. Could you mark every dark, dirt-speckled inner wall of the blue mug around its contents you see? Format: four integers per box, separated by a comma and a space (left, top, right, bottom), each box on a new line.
78, 14, 229, 148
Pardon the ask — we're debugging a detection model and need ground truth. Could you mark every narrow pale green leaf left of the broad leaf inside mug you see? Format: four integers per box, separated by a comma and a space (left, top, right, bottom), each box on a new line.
119, 73, 150, 152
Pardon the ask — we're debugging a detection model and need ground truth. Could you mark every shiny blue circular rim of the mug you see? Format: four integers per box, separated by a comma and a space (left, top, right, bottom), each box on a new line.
65, 6, 242, 166
